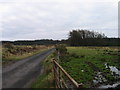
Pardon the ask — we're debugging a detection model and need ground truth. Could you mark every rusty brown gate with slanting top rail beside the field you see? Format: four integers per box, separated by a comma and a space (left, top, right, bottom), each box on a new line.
53, 59, 82, 89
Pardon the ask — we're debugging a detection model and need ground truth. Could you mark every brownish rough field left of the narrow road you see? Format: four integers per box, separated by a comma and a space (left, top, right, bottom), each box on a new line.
2, 45, 51, 64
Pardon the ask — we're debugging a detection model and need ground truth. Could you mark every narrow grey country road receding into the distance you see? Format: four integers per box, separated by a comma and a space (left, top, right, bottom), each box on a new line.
2, 49, 55, 88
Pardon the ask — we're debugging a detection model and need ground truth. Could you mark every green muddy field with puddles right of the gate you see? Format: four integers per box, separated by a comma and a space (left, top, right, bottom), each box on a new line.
61, 47, 120, 87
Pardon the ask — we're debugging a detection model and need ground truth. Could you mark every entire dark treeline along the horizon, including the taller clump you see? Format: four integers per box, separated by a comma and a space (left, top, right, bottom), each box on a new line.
2, 29, 120, 46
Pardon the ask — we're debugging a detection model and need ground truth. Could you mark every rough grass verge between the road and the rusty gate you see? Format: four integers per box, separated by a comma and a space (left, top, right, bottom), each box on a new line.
31, 54, 54, 89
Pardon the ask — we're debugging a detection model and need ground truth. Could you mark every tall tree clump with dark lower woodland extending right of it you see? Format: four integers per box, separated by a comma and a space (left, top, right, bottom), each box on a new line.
68, 30, 120, 46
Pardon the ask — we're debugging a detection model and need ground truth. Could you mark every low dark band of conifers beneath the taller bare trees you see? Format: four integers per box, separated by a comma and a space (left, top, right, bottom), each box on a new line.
69, 38, 120, 46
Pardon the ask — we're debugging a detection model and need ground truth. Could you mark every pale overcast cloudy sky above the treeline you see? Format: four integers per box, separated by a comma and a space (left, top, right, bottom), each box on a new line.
0, 0, 119, 41
